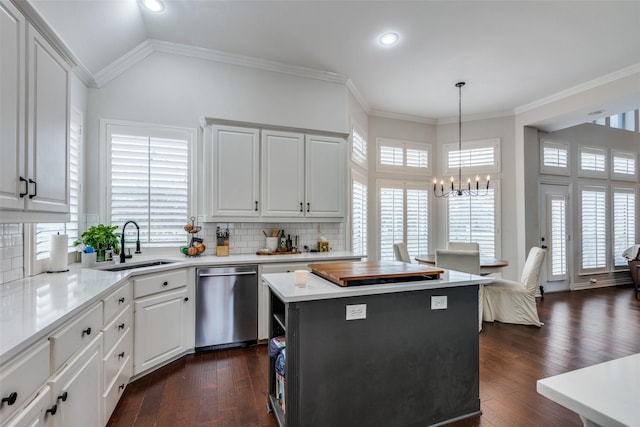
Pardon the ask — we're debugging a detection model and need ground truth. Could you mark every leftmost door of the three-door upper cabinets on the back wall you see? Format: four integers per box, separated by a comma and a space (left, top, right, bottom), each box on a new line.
203, 125, 260, 216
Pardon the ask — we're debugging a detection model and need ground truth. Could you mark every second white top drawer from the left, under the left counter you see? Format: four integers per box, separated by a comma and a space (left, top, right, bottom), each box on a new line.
49, 302, 102, 373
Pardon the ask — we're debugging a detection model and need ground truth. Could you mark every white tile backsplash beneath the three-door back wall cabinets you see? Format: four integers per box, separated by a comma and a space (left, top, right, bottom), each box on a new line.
199, 222, 345, 255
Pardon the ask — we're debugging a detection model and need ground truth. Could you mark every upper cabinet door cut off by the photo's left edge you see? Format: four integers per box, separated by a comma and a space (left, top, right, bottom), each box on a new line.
0, 0, 27, 209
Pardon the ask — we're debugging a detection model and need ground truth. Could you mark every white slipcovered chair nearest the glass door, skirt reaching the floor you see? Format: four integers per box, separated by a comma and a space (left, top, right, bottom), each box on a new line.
482, 246, 547, 327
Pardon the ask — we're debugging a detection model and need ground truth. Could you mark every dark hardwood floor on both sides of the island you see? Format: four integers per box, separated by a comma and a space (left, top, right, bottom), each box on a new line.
108, 287, 640, 427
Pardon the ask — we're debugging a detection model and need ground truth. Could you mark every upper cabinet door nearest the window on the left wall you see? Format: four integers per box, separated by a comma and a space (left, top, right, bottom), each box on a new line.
25, 27, 70, 213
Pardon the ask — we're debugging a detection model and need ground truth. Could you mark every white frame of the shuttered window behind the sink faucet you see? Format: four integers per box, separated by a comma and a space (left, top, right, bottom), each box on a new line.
99, 119, 199, 250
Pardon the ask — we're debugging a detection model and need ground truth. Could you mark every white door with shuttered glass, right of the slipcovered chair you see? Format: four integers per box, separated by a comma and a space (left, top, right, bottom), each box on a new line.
538, 184, 572, 290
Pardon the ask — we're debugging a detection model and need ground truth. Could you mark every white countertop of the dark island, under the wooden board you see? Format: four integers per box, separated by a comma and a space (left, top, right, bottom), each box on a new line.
262, 270, 493, 303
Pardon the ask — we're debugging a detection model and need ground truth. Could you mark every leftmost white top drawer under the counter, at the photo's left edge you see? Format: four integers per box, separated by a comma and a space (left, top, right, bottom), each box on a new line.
0, 341, 50, 420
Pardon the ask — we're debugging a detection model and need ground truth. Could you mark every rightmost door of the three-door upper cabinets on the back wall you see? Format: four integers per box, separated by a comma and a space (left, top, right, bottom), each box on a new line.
305, 135, 346, 217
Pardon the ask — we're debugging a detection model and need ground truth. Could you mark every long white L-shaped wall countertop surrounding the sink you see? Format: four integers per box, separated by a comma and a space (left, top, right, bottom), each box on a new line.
0, 251, 360, 363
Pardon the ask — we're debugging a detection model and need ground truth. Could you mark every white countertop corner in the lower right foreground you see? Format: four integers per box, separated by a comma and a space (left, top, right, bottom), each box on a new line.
537, 353, 640, 427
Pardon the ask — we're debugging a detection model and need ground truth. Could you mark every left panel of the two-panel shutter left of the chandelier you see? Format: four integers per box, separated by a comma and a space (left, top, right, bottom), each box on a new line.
380, 187, 404, 261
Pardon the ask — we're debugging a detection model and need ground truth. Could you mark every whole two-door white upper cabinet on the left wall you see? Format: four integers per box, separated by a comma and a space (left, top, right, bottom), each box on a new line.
0, 0, 70, 222
